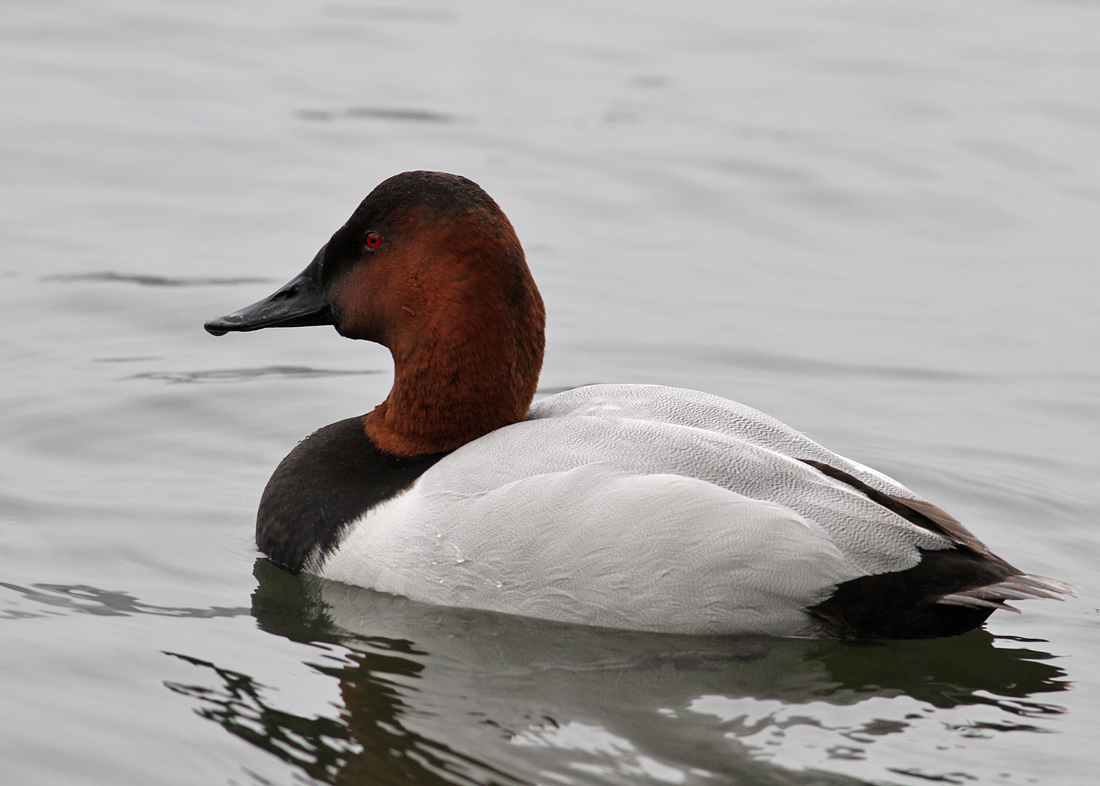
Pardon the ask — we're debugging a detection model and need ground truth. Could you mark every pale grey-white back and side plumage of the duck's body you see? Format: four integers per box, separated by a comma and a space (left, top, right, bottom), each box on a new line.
311, 385, 950, 635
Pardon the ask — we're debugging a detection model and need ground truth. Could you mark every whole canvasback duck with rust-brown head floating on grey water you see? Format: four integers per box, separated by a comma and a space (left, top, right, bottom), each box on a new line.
206, 171, 1071, 639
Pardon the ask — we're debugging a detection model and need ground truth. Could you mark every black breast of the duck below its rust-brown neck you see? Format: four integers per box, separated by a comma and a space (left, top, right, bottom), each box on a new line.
256, 418, 447, 573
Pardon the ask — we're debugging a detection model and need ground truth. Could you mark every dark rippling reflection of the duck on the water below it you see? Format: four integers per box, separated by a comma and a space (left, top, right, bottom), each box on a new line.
168, 561, 1069, 784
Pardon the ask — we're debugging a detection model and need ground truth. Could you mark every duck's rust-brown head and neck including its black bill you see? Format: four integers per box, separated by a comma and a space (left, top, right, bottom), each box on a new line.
206, 171, 546, 455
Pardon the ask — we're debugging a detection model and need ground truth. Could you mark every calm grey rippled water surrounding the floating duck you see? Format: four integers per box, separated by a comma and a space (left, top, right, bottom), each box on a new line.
0, 0, 1100, 785
